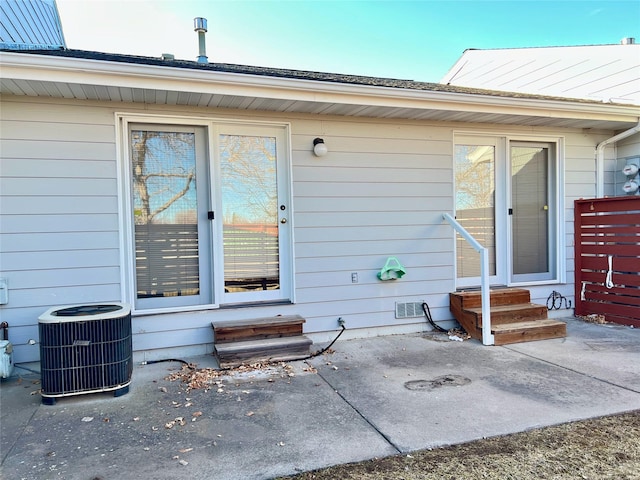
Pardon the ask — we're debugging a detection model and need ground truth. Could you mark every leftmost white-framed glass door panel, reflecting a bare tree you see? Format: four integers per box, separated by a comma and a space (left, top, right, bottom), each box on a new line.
130, 125, 211, 309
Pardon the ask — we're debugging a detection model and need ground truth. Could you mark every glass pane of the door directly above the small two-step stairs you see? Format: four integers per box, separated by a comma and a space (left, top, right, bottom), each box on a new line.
219, 135, 280, 293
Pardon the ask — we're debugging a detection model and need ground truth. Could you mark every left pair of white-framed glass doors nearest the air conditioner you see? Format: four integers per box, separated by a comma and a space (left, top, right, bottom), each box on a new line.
123, 118, 292, 310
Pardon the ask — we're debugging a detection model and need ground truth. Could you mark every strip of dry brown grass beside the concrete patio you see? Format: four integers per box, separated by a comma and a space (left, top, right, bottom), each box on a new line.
279, 410, 640, 480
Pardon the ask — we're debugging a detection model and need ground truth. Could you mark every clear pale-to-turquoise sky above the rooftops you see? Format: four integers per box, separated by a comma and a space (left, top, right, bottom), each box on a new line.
57, 0, 640, 82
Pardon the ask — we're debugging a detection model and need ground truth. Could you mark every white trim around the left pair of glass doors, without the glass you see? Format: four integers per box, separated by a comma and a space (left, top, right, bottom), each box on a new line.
115, 112, 296, 315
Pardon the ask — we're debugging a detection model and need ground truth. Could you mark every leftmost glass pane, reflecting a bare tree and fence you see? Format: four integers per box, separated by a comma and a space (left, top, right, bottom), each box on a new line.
131, 130, 200, 298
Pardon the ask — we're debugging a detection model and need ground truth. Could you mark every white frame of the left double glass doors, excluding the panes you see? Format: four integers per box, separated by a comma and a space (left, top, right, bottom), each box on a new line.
115, 112, 295, 315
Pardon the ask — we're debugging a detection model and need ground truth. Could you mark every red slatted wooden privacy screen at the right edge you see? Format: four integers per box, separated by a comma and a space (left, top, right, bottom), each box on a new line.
575, 196, 640, 327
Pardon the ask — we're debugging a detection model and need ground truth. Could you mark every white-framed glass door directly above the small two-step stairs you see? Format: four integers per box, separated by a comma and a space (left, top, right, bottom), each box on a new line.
217, 126, 290, 303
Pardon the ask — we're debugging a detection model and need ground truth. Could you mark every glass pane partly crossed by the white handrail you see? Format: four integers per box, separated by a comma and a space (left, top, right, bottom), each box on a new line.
455, 145, 496, 278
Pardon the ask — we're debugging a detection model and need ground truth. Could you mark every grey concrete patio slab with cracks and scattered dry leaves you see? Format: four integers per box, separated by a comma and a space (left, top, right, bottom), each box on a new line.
0, 319, 640, 480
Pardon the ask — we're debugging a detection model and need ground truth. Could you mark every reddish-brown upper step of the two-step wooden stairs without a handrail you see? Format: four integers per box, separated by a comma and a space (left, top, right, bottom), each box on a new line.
211, 315, 305, 345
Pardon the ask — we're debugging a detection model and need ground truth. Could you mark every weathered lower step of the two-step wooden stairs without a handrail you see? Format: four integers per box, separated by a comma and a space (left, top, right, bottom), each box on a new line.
214, 335, 313, 368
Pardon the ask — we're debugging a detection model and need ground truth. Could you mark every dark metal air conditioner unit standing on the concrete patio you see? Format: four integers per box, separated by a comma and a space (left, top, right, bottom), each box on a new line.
38, 303, 133, 405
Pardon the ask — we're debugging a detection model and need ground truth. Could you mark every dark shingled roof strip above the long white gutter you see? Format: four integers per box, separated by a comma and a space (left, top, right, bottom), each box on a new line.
1, 49, 616, 103
